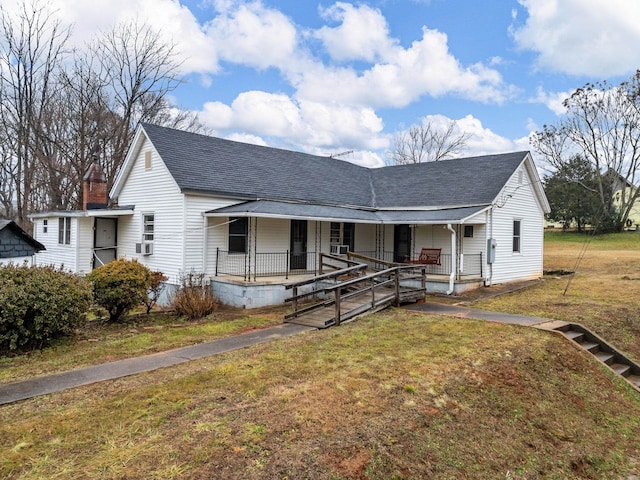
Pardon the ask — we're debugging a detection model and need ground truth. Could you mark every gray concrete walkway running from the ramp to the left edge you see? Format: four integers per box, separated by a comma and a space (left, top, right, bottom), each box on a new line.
0, 323, 315, 405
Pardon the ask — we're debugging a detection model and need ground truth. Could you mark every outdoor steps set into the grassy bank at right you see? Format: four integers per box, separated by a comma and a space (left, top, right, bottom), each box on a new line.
553, 323, 640, 391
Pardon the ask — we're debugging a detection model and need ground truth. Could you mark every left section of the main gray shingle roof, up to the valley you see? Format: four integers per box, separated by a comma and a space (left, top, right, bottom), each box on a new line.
143, 124, 372, 205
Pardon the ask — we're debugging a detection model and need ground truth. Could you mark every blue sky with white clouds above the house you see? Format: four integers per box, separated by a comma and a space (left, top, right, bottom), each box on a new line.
18, 0, 640, 166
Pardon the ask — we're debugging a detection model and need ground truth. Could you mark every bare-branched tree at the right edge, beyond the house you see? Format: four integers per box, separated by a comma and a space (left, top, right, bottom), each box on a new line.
532, 72, 640, 230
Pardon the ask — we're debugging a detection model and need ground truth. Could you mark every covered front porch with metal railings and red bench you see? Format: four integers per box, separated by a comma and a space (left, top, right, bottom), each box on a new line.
205, 201, 486, 306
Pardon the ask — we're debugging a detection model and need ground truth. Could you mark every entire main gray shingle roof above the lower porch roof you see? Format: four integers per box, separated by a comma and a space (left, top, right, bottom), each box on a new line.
142, 124, 527, 208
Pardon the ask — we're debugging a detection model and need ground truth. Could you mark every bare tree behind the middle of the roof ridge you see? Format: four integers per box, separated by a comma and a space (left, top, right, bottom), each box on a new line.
387, 121, 469, 165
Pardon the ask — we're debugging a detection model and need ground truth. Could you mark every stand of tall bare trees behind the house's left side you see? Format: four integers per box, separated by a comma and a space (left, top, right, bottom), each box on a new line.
0, 5, 205, 220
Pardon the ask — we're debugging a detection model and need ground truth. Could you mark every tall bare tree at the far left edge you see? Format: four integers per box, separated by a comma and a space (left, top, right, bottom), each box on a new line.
0, 1, 69, 226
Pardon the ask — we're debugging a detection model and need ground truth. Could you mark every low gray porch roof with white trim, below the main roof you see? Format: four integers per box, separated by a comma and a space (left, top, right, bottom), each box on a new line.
205, 200, 489, 225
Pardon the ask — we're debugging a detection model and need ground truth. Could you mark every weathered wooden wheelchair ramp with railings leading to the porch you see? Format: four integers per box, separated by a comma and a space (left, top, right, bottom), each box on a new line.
284, 255, 426, 328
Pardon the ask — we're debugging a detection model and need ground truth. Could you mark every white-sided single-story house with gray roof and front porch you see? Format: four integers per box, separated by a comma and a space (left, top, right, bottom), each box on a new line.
32, 124, 549, 307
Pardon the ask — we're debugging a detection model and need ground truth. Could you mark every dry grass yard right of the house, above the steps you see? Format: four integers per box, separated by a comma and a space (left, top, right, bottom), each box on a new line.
474, 232, 640, 362
